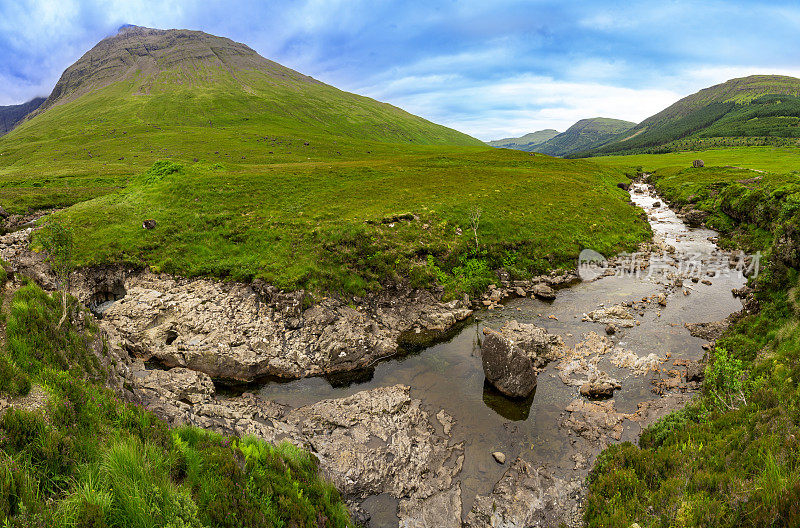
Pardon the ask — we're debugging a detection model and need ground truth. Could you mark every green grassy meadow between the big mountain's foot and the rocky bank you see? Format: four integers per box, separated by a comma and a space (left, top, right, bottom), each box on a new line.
12, 150, 649, 293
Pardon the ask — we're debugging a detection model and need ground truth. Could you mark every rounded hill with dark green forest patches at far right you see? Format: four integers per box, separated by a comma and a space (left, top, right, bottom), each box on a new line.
593, 75, 800, 154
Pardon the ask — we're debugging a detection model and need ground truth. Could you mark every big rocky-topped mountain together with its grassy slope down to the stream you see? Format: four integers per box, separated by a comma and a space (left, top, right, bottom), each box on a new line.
0, 28, 648, 294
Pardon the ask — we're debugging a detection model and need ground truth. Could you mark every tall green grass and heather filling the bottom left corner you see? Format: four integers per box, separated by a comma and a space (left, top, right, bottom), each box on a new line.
0, 278, 352, 528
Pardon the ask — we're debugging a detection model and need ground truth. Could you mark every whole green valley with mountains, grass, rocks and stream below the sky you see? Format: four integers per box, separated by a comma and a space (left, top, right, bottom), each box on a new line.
0, 21, 800, 528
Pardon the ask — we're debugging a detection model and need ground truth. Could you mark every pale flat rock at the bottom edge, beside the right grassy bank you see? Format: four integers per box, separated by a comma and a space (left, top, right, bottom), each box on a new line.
464, 458, 580, 528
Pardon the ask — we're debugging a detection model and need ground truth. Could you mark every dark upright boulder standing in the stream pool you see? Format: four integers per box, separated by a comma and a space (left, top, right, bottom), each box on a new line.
481, 328, 536, 398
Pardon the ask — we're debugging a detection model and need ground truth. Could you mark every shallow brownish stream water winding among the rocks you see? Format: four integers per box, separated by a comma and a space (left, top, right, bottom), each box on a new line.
260, 184, 745, 528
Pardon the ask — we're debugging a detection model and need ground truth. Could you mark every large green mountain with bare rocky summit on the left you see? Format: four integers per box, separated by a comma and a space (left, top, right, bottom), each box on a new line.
9, 26, 481, 146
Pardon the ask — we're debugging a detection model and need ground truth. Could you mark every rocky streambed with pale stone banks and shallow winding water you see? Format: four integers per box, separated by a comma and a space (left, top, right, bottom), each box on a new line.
0, 180, 743, 527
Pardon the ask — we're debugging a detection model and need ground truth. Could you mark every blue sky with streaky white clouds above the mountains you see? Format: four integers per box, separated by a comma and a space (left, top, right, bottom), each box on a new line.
0, 0, 800, 140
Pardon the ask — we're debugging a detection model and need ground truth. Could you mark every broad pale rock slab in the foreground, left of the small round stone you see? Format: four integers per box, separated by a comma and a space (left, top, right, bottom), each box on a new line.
283, 385, 464, 499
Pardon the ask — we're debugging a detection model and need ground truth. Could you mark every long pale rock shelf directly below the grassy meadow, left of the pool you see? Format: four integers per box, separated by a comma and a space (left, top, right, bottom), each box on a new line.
65, 270, 472, 381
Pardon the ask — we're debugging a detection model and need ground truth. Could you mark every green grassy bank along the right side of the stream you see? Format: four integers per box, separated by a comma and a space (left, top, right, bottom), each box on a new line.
586, 148, 800, 528
